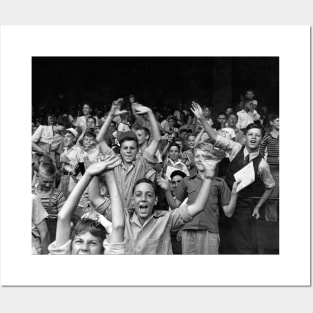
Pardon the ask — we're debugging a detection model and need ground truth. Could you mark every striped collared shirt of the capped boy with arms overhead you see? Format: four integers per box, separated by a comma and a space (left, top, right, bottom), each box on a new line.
111, 150, 156, 209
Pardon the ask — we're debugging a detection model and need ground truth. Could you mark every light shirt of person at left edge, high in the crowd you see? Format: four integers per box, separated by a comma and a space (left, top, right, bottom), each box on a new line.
32, 125, 63, 152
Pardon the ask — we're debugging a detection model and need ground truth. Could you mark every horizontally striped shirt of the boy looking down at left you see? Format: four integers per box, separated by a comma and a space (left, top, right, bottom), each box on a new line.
33, 184, 65, 218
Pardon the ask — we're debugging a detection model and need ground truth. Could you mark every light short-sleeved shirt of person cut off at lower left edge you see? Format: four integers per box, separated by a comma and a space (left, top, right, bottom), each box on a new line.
32, 194, 48, 254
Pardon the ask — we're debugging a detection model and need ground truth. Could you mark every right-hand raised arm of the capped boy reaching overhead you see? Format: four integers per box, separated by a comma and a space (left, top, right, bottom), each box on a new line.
133, 103, 161, 155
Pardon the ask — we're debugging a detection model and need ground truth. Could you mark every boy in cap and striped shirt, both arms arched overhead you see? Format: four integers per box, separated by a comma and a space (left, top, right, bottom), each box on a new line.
97, 99, 161, 210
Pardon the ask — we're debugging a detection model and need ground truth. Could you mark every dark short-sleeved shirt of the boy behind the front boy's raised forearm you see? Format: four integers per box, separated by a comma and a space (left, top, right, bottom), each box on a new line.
175, 173, 231, 233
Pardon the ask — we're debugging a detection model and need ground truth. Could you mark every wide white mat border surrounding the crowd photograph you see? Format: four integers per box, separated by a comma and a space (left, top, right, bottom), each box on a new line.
1, 26, 310, 286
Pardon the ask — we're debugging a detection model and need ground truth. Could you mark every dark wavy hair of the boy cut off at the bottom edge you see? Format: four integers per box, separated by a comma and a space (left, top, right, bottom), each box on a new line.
71, 218, 108, 242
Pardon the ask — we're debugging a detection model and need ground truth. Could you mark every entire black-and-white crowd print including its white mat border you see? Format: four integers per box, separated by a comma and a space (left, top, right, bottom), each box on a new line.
1, 26, 310, 286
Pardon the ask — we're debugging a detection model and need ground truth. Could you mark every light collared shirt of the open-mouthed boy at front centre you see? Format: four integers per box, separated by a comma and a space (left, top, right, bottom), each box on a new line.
125, 205, 192, 254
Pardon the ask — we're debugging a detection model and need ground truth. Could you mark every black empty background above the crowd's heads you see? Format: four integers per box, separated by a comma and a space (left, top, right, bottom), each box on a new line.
32, 57, 279, 116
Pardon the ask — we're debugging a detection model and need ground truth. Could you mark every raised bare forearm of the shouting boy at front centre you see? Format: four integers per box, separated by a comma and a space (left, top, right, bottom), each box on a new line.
188, 157, 217, 216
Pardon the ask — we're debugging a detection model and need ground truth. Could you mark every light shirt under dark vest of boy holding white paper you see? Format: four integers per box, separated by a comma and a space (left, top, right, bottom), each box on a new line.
215, 135, 275, 188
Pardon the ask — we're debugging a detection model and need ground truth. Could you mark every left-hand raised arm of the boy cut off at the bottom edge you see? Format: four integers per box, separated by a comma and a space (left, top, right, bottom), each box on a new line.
55, 155, 121, 247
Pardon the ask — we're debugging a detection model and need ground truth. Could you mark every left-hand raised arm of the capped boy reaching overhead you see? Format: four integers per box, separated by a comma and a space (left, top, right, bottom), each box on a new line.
96, 98, 127, 155
